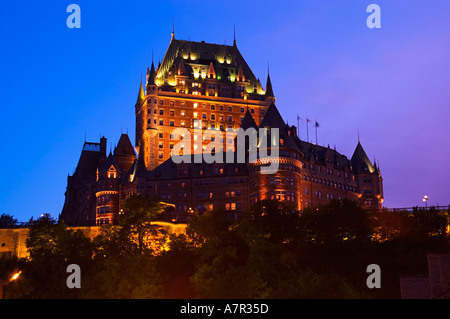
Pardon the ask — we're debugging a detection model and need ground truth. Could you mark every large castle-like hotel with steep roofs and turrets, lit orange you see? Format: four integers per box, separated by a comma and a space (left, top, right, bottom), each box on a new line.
60, 33, 383, 226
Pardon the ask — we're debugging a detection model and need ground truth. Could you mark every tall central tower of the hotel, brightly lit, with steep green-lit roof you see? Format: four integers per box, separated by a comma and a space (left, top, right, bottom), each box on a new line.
135, 33, 275, 170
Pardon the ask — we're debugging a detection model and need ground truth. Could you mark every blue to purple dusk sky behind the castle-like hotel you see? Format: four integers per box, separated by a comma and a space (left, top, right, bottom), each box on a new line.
0, 0, 450, 221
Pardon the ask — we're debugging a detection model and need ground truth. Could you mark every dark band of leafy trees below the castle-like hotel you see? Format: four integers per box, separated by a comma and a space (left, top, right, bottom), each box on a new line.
0, 199, 450, 298
